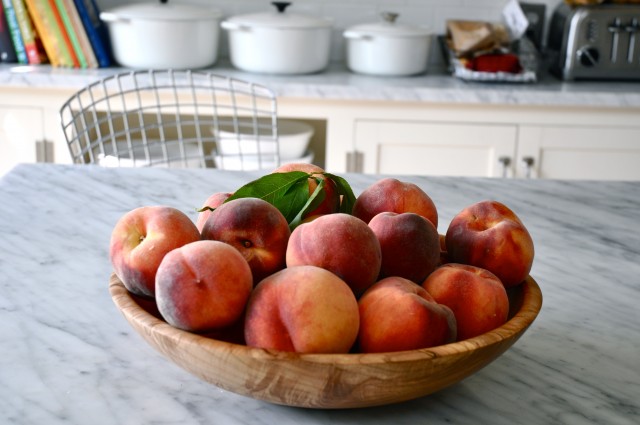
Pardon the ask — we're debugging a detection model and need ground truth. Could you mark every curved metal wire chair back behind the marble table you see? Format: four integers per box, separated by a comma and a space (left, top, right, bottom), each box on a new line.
60, 70, 280, 169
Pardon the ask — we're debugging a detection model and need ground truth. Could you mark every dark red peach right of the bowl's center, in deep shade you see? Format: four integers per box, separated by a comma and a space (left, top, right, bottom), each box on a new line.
369, 212, 440, 284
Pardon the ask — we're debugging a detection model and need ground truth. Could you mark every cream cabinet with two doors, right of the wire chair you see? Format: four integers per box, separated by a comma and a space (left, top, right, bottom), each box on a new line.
347, 106, 640, 180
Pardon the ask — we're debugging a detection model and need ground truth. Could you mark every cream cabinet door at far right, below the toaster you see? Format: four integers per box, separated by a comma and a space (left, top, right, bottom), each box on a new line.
516, 126, 640, 180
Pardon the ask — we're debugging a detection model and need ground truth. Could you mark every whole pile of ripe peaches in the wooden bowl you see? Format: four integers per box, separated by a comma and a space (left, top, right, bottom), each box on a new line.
110, 164, 534, 353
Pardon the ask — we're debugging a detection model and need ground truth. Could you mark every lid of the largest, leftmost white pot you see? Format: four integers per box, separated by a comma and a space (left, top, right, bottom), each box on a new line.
100, 1, 222, 21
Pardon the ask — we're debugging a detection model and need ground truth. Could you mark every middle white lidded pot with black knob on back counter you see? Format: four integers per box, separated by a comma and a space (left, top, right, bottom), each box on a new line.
221, 2, 332, 74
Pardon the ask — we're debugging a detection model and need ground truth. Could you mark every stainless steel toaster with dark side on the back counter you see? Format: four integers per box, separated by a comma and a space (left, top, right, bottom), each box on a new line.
547, 2, 640, 80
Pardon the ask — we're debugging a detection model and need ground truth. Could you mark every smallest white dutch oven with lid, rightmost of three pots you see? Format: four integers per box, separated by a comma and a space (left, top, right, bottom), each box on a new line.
343, 12, 432, 76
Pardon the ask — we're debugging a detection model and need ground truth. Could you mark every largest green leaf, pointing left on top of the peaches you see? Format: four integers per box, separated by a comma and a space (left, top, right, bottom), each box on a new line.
225, 171, 310, 223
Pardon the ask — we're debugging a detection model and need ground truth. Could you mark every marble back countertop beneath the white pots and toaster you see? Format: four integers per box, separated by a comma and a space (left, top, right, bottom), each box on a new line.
0, 62, 640, 108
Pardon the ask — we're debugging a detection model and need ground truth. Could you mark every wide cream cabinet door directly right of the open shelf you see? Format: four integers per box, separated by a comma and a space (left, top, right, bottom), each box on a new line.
355, 120, 517, 177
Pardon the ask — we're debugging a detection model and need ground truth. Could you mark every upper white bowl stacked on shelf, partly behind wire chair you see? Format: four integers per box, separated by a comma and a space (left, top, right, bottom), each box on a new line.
217, 119, 314, 160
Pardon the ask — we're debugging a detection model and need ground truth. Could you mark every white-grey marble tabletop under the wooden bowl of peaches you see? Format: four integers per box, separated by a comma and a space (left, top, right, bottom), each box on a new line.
0, 164, 640, 425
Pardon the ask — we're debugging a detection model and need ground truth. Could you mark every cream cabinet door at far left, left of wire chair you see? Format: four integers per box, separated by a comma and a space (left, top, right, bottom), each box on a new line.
0, 106, 43, 175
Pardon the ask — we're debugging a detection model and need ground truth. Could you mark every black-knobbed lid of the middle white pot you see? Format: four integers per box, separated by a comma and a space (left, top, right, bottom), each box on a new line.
227, 2, 332, 29
